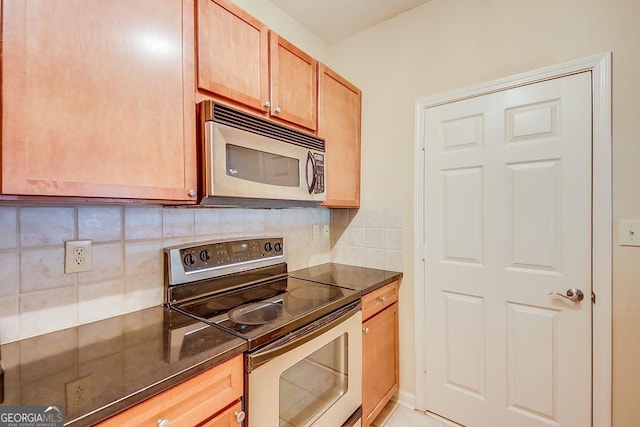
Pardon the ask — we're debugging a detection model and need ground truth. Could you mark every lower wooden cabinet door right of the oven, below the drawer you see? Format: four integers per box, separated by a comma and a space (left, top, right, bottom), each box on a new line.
362, 303, 399, 427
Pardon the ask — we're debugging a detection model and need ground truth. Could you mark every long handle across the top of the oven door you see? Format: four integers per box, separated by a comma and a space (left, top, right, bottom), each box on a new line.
246, 300, 362, 372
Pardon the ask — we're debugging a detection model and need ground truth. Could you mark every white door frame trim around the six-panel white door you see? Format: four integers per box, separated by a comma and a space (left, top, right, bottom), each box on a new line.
413, 52, 612, 427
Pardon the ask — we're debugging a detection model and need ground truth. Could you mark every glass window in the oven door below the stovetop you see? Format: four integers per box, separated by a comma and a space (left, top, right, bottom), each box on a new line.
279, 334, 349, 427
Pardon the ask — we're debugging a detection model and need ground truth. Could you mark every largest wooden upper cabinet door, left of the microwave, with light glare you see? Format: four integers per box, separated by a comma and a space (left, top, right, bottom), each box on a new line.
2, 0, 196, 200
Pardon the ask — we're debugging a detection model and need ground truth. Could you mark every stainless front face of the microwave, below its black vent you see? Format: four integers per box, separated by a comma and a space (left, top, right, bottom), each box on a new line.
204, 121, 326, 202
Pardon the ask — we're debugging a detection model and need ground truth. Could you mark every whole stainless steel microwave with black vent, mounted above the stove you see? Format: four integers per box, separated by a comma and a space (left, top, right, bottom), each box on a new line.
198, 100, 326, 207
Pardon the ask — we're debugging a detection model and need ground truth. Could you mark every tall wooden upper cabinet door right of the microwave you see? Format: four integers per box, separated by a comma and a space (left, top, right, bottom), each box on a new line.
318, 64, 362, 208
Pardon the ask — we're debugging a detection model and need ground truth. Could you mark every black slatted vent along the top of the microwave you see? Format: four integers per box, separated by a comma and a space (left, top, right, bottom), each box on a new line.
212, 102, 325, 151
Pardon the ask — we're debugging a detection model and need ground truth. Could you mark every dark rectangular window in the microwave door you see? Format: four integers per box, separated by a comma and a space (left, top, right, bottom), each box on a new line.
226, 144, 300, 187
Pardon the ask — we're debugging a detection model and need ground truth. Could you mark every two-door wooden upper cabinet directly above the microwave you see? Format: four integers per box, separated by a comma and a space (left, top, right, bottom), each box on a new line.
196, 0, 318, 131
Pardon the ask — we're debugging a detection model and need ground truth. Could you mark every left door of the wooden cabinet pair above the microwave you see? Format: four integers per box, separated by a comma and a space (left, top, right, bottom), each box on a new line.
196, 0, 269, 111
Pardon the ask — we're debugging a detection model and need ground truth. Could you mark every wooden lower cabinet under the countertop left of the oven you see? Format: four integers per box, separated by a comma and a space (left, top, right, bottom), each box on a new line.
98, 355, 244, 427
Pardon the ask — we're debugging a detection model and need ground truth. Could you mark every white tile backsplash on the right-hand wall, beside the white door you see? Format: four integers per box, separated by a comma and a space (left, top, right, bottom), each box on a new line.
331, 208, 404, 272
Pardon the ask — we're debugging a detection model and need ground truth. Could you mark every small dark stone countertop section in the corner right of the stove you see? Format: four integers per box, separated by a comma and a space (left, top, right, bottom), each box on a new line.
289, 263, 402, 295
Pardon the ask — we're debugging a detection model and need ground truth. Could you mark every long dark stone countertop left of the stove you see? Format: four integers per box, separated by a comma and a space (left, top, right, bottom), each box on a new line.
0, 307, 246, 426
